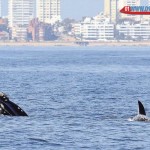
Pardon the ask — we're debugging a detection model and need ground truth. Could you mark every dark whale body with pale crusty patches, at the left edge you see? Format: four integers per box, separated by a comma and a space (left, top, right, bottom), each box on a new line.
0, 92, 28, 116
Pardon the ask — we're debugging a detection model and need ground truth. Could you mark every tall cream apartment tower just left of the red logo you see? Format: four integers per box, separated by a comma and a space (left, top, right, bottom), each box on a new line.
104, 0, 118, 23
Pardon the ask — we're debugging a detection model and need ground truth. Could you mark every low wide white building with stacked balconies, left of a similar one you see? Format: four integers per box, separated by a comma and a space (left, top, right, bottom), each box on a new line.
73, 14, 114, 41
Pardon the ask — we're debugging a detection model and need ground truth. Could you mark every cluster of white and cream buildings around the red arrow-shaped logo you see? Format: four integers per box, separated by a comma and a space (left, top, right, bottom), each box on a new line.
72, 0, 150, 41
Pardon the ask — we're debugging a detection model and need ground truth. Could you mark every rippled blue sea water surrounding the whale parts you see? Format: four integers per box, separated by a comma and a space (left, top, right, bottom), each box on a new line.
0, 46, 150, 150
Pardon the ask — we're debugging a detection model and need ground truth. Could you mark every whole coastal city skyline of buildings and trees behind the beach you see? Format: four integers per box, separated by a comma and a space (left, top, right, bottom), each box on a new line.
0, 0, 150, 42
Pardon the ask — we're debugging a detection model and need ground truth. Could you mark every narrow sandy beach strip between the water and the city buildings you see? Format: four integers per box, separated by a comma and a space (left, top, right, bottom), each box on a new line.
0, 41, 150, 47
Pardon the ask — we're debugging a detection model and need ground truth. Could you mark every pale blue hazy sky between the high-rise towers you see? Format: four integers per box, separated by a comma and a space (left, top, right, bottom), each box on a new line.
2, 0, 103, 20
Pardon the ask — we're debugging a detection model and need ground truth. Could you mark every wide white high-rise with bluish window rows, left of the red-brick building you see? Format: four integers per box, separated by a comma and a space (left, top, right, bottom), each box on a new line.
8, 0, 34, 40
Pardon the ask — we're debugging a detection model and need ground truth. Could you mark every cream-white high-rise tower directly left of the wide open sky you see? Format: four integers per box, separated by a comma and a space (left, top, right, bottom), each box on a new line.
36, 0, 61, 24
